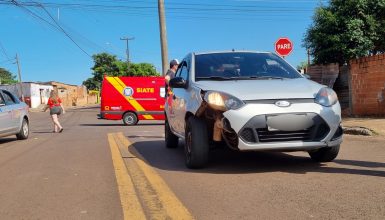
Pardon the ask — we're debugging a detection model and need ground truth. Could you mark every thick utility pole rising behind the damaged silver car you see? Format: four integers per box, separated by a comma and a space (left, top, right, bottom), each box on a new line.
158, 0, 168, 76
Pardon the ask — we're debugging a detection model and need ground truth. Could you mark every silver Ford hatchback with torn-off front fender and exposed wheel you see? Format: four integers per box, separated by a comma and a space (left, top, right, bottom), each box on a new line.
165, 51, 342, 168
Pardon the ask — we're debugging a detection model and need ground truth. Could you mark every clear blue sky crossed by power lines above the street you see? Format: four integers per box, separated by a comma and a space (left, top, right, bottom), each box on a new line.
0, 0, 327, 85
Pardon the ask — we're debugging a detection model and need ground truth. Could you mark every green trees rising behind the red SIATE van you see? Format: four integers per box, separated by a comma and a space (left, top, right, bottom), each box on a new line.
83, 53, 159, 90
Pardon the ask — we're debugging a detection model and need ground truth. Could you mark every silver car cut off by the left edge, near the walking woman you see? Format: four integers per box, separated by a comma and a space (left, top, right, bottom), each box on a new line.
0, 89, 29, 140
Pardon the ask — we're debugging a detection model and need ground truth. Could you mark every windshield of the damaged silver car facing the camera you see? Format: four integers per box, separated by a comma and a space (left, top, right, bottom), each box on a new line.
195, 52, 301, 81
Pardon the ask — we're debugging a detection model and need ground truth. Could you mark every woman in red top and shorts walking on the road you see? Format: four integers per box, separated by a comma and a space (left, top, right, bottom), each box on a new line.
47, 90, 65, 133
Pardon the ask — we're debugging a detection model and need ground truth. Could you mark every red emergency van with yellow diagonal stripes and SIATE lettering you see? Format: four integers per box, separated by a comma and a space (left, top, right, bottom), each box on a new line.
99, 76, 166, 125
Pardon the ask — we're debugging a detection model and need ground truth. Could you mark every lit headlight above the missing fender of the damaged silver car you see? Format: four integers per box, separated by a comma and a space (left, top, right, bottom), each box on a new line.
204, 91, 245, 111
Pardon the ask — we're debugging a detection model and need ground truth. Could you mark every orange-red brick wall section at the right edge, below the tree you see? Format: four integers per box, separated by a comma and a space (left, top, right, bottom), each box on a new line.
350, 54, 385, 116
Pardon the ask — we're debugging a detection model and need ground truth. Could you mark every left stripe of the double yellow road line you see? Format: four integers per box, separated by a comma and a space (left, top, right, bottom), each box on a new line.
108, 134, 146, 220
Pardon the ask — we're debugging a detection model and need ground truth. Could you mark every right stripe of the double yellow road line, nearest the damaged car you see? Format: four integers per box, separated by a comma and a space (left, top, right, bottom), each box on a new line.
116, 132, 194, 219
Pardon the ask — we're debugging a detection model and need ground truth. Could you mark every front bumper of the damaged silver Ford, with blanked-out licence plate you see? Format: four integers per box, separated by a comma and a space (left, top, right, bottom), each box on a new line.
223, 103, 342, 151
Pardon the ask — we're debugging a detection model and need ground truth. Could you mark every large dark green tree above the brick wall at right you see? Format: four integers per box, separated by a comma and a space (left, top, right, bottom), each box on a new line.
303, 0, 385, 64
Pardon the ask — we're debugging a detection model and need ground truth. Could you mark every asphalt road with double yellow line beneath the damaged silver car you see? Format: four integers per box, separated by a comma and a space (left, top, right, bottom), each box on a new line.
0, 108, 385, 220
